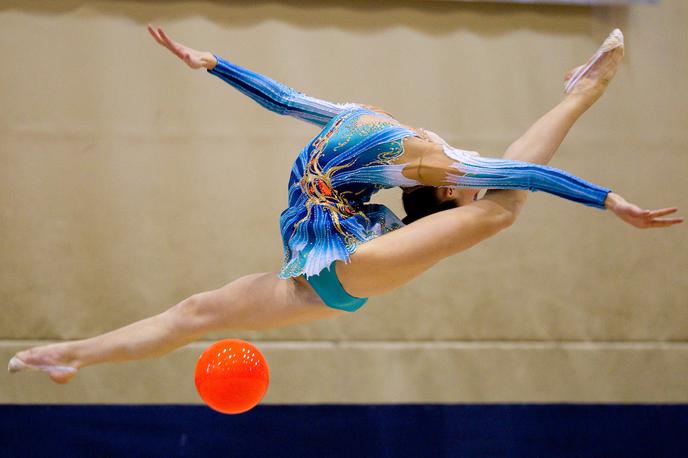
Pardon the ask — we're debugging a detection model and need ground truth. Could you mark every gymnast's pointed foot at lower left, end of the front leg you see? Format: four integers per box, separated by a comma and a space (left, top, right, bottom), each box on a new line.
7, 344, 78, 383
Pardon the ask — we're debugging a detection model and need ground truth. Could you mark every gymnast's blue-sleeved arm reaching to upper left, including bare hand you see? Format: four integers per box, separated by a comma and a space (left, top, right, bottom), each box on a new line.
148, 24, 356, 127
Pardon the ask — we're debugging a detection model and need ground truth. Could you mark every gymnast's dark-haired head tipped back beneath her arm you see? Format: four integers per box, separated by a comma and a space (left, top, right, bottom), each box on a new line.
401, 186, 480, 224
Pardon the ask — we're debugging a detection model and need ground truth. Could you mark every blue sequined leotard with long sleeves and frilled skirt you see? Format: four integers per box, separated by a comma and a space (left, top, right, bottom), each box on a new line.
208, 56, 610, 278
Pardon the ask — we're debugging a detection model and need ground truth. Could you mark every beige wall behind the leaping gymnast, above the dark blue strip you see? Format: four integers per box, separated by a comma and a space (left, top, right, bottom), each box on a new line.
0, 0, 688, 403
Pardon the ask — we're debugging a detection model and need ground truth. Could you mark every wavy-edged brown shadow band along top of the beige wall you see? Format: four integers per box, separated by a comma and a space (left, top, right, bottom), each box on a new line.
0, 0, 628, 36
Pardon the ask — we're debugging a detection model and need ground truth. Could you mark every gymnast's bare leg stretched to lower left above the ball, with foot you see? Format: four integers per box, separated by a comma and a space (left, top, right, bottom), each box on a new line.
5, 273, 344, 383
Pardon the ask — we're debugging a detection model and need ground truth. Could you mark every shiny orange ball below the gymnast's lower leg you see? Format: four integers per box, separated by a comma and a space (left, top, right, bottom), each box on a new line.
195, 339, 270, 413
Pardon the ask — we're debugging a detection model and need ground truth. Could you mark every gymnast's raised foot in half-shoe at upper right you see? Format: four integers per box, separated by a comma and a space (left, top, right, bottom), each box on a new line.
564, 29, 624, 107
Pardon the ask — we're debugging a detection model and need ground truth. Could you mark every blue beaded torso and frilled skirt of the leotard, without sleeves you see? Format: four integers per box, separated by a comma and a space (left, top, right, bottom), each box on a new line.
280, 107, 418, 278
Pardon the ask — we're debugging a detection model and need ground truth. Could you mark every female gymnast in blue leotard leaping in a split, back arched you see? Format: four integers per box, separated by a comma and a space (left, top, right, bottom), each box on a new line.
9, 25, 683, 383
